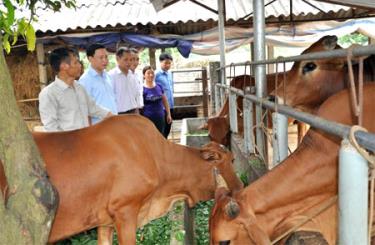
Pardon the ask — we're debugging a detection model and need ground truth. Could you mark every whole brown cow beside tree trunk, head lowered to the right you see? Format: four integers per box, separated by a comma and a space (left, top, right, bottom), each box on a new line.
0, 115, 242, 244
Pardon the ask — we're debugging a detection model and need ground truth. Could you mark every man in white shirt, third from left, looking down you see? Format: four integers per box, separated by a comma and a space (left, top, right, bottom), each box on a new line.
108, 47, 141, 114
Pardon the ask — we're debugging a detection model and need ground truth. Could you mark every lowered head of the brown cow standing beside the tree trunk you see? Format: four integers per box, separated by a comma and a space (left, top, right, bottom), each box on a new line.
201, 142, 243, 193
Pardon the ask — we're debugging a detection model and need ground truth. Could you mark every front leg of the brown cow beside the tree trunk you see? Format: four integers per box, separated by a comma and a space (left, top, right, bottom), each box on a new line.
115, 207, 138, 245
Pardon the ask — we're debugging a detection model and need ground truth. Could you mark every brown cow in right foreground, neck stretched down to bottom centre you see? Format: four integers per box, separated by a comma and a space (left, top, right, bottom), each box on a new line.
210, 84, 375, 245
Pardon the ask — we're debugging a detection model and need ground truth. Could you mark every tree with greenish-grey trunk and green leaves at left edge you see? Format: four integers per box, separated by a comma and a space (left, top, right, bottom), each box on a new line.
0, 0, 75, 244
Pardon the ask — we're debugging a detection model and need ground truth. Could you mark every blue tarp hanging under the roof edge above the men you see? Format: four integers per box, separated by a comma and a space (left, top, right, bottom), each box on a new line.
38, 33, 193, 58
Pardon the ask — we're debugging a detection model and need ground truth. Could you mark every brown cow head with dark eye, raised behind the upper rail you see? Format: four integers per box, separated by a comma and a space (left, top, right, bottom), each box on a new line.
271, 36, 345, 111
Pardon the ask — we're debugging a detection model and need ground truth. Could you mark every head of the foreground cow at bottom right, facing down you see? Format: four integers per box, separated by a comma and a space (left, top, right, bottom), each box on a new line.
209, 188, 271, 245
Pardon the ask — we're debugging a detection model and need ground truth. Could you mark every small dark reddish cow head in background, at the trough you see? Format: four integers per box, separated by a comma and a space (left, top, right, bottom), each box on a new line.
207, 115, 229, 145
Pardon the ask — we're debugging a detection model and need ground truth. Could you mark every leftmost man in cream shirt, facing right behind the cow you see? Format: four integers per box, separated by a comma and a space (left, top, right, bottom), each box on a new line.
39, 48, 112, 131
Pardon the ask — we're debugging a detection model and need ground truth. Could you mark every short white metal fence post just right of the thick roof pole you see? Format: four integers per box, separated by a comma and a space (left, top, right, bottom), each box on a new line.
272, 112, 288, 167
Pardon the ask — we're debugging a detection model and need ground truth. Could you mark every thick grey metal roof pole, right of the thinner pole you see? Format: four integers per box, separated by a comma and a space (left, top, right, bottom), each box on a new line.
253, 0, 268, 160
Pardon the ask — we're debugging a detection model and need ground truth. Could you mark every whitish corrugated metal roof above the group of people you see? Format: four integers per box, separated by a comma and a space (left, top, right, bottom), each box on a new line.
30, 0, 374, 35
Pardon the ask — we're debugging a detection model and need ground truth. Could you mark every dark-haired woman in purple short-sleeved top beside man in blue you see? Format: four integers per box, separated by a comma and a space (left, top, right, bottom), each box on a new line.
143, 66, 172, 134
